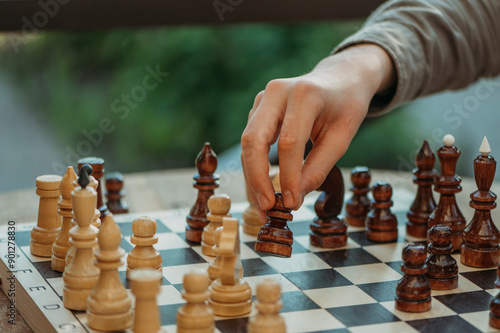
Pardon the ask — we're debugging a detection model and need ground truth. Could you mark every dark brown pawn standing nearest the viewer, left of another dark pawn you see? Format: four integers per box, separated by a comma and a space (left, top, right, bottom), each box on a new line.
396, 243, 431, 312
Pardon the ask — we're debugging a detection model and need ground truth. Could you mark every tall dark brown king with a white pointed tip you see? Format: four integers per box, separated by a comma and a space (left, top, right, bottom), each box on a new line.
460, 137, 500, 267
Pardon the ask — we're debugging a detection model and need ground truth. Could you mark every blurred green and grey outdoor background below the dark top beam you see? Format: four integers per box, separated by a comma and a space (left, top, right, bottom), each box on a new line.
0, 10, 500, 192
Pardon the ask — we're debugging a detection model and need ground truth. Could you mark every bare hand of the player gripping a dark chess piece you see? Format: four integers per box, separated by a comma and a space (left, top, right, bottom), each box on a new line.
241, 44, 395, 220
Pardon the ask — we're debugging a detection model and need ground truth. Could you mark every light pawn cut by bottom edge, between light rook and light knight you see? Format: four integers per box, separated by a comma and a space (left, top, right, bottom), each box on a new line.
177, 270, 215, 333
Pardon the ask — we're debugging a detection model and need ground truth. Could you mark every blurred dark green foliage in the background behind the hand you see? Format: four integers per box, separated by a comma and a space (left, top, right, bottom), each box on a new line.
0, 22, 420, 172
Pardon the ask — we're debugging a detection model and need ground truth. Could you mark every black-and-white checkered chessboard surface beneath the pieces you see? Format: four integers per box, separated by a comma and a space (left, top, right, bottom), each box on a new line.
0, 190, 498, 333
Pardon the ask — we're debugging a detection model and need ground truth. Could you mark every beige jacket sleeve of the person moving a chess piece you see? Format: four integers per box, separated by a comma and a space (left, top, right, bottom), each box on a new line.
333, 0, 500, 115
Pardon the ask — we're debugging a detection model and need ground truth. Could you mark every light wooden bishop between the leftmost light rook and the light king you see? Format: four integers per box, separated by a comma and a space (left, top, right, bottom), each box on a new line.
50, 166, 76, 272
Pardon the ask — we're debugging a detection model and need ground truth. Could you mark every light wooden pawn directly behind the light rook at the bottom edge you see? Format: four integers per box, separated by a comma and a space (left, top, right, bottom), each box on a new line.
127, 216, 163, 279
